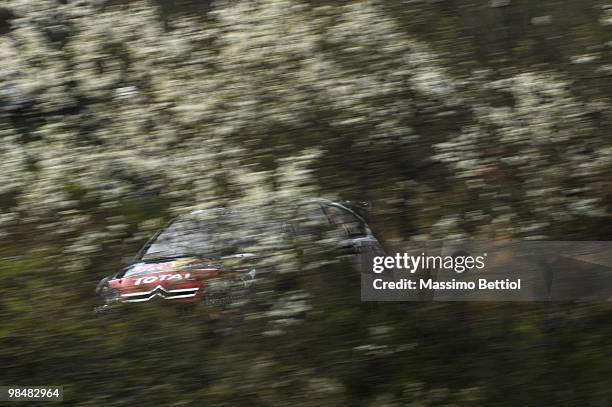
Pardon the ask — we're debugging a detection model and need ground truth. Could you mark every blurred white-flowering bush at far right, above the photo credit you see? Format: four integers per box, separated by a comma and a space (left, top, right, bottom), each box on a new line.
434, 73, 607, 237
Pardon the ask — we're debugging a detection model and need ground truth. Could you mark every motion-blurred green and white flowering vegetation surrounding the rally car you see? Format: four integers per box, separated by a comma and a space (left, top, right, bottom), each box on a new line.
0, 0, 612, 406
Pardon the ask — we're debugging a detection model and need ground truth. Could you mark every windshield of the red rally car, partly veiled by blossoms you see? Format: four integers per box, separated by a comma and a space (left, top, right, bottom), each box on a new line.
141, 213, 250, 262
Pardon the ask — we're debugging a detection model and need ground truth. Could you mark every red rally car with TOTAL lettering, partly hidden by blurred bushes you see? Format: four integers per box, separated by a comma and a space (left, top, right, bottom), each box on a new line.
96, 199, 384, 312
